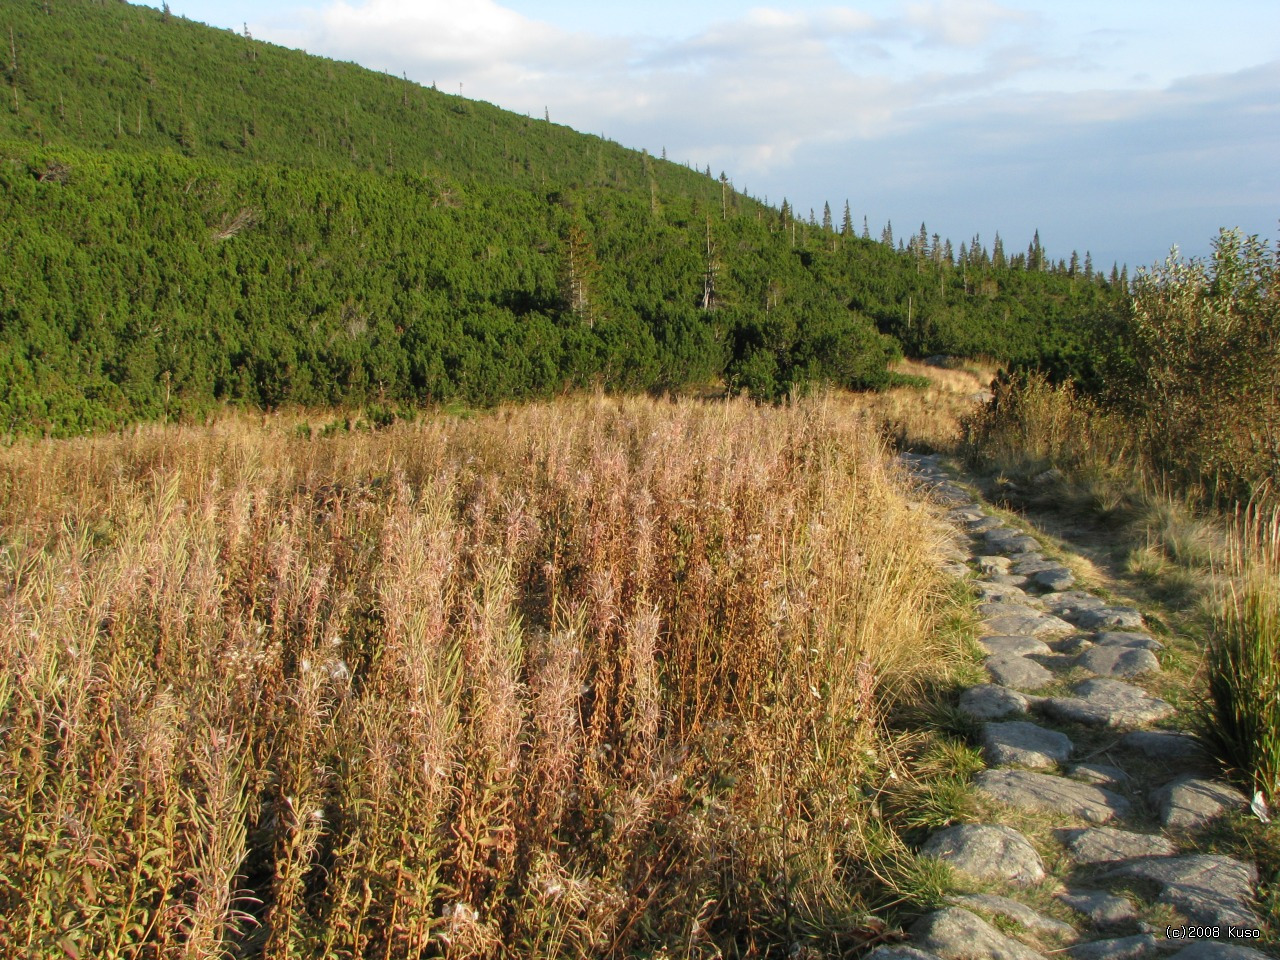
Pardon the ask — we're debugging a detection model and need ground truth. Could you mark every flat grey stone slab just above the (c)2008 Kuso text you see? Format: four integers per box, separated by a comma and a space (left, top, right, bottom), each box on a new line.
1105, 854, 1260, 928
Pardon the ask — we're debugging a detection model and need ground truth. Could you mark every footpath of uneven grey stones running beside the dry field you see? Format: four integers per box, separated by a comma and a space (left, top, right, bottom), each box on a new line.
869, 453, 1266, 960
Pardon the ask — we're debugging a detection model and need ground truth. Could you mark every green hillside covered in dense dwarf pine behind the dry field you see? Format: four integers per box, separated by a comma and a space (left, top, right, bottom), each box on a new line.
0, 0, 1123, 434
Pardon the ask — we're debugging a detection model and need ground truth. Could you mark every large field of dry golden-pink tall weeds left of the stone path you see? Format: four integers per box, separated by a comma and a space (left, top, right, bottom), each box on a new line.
0, 397, 955, 959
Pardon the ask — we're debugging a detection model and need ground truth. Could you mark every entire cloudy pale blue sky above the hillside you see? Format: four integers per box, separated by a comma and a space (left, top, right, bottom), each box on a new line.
145, 0, 1280, 269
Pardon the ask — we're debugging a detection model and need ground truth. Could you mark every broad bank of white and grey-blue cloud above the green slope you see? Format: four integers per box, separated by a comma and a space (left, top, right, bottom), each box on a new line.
254, 0, 1280, 262
